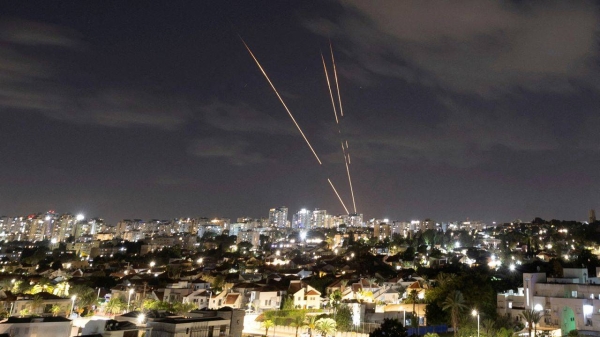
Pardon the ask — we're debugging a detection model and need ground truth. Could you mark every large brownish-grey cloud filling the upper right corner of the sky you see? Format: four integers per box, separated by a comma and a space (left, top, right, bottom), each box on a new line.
307, 0, 599, 96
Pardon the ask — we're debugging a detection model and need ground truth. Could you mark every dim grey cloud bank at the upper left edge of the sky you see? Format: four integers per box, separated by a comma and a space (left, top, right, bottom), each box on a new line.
0, 20, 191, 130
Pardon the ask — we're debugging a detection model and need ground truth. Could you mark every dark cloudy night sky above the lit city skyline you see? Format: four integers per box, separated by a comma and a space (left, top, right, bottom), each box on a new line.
0, 0, 600, 223
